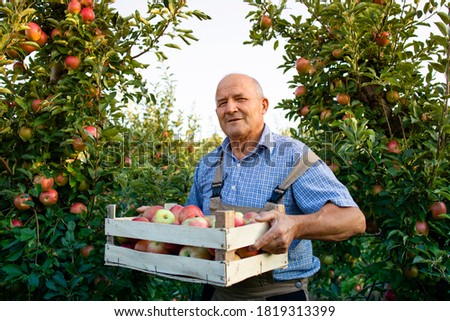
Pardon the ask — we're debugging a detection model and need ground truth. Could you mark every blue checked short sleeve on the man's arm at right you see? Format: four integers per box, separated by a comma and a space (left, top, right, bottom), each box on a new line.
292, 160, 358, 214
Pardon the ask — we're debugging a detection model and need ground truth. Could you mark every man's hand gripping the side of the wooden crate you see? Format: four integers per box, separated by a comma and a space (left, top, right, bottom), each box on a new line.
249, 210, 296, 254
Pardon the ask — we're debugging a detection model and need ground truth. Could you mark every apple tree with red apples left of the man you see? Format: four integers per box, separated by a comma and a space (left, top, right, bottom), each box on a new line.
0, 0, 209, 300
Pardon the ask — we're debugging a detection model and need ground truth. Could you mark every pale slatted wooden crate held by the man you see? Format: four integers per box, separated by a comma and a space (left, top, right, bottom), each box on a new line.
105, 205, 287, 286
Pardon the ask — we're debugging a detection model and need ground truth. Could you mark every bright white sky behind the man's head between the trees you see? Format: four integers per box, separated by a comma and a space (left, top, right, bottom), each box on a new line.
111, 0, 293, 137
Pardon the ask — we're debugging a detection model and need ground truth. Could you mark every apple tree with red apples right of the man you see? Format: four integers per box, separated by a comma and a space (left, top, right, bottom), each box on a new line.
245, 0, 450, 300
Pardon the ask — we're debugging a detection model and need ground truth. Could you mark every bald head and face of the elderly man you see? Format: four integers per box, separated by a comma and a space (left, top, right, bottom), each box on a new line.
216, 75, 268, 142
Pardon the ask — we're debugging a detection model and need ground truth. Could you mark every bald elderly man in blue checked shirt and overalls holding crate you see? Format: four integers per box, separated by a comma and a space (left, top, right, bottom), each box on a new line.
187, 74, 365, 300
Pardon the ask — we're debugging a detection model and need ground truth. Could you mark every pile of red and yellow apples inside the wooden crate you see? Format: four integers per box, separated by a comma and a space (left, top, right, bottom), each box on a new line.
117, 204, 261, 260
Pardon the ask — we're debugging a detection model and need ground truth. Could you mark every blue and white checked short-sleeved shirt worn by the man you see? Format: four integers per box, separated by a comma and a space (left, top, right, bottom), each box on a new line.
186, 125, 357, 281
